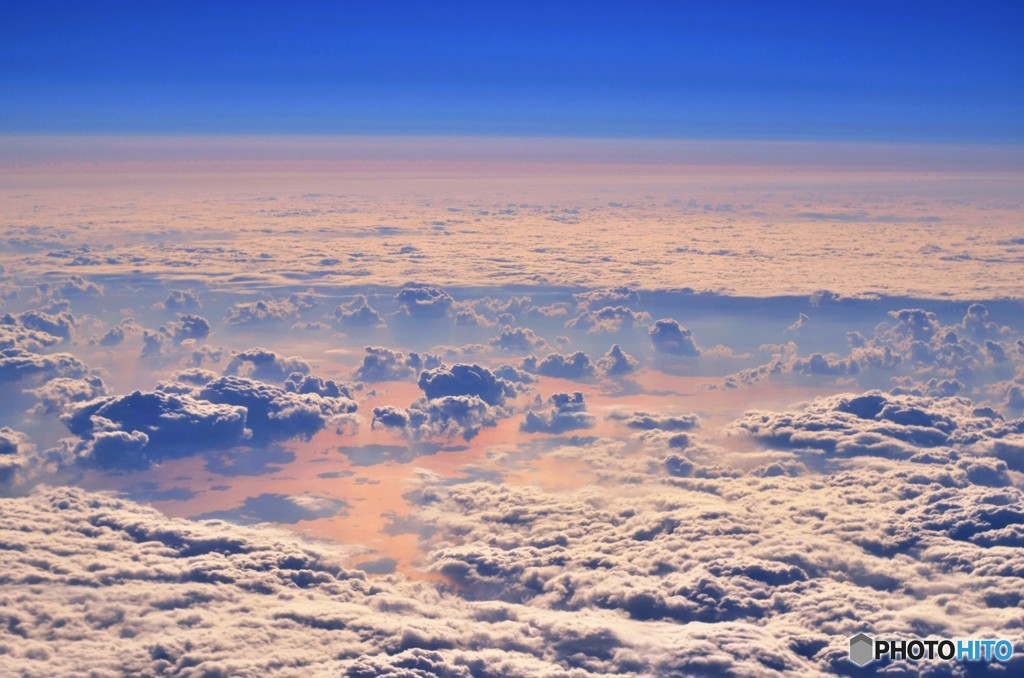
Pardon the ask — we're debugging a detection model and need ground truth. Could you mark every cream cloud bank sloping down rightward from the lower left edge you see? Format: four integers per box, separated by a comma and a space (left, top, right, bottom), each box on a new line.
0, 488, 835, 678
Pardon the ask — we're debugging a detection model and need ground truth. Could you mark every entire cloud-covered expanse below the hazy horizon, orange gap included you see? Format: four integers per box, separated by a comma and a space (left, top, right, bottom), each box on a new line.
0, 151, 1024, 678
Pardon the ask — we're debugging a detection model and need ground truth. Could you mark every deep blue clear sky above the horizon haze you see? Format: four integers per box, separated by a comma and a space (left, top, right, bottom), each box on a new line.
0, 0, 1024, 143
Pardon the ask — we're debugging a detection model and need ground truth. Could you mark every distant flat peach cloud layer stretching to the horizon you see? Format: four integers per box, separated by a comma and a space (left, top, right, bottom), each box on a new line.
0, 150, 1024, 301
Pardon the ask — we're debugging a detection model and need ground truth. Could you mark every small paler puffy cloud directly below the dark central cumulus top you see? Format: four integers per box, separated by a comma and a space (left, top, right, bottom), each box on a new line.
372, 395, 504, 440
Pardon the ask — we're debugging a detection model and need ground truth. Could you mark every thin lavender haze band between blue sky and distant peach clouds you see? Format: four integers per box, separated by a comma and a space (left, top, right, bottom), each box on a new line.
0, 132, 1024, 173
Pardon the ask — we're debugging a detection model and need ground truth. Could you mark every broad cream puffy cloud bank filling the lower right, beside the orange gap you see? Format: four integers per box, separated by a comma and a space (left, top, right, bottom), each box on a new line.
420, 403, 1024, 675
